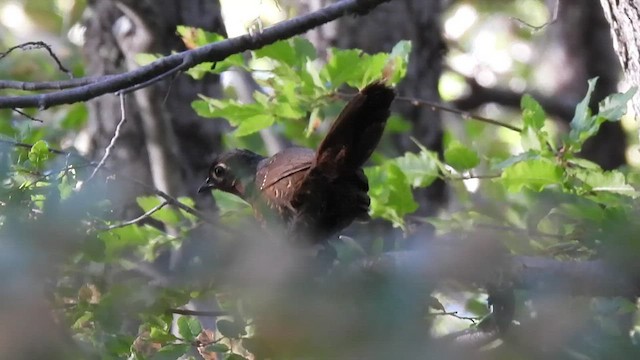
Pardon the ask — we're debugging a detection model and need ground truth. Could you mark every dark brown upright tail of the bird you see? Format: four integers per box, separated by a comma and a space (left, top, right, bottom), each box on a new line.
315, 82, 396, 178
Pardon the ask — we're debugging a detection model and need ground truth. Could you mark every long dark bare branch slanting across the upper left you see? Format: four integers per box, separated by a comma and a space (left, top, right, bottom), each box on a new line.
0, 0, 390, 109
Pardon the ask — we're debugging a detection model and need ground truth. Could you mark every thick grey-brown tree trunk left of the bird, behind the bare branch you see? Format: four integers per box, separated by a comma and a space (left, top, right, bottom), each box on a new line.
84, 0, 225, 216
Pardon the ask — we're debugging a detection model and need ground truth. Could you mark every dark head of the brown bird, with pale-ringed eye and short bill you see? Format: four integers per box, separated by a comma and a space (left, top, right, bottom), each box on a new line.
198, 149, 264, 198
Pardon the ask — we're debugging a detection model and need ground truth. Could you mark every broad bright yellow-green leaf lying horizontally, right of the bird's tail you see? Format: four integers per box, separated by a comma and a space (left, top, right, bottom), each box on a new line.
501, 158, 562, 192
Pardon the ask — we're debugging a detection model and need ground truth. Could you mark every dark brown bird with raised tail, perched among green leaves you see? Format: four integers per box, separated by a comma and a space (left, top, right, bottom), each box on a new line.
198, 82, 395, 243
